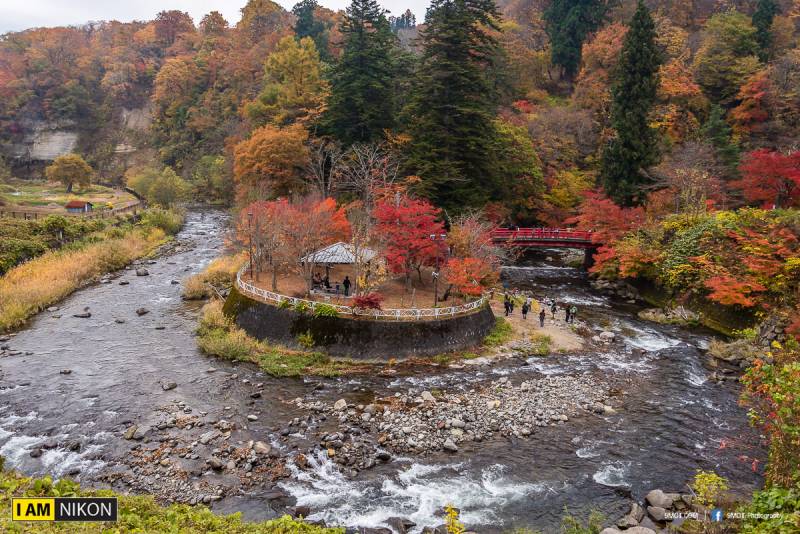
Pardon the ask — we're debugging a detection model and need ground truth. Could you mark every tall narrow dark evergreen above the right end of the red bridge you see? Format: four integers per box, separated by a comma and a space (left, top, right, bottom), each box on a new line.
601, 0, 663, 206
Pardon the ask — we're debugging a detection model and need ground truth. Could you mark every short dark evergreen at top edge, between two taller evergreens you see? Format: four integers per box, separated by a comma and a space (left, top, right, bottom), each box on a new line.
544, 0, 608, 78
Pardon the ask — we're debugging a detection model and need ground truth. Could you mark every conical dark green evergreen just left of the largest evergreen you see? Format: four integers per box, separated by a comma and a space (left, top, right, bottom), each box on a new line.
325, 0, 396, 144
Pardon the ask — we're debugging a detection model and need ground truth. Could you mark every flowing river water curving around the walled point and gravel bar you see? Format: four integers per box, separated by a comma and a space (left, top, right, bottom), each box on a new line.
0, 212, 764, 532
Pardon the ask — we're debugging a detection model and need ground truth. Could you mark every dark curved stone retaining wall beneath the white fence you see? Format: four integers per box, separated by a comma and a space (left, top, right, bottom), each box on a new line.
224, 288, 495, 360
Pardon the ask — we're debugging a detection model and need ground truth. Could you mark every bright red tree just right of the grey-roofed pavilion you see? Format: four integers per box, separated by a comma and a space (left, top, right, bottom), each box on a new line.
372, 195, 445, 292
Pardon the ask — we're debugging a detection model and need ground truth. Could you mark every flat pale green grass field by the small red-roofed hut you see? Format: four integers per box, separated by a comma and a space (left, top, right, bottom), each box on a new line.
0, 180, 136, 212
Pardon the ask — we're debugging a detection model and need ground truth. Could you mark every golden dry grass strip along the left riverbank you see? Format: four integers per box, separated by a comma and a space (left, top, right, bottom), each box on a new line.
0, 228, 166, 332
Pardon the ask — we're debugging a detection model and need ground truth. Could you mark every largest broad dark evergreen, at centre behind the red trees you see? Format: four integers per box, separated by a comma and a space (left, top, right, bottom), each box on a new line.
407, 0, 499, 210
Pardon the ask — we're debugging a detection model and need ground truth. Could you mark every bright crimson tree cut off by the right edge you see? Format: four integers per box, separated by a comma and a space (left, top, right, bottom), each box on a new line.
731, 149, 800, 208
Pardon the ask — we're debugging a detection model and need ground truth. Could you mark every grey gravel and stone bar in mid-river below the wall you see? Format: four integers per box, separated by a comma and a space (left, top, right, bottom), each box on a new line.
294, 376, 614, 460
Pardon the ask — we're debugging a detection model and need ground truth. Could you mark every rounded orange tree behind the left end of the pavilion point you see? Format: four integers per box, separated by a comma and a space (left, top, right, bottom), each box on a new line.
233, 124, 309, 202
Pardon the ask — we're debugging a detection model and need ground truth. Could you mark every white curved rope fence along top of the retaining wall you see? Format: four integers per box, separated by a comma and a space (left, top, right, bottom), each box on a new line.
236, 264, 487, 321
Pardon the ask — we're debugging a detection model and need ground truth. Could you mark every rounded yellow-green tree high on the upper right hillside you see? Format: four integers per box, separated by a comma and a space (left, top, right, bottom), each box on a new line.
694, 11, 759, 104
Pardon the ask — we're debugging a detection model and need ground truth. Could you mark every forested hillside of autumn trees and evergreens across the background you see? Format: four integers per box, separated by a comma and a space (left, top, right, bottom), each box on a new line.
0, 0, 800, 219
